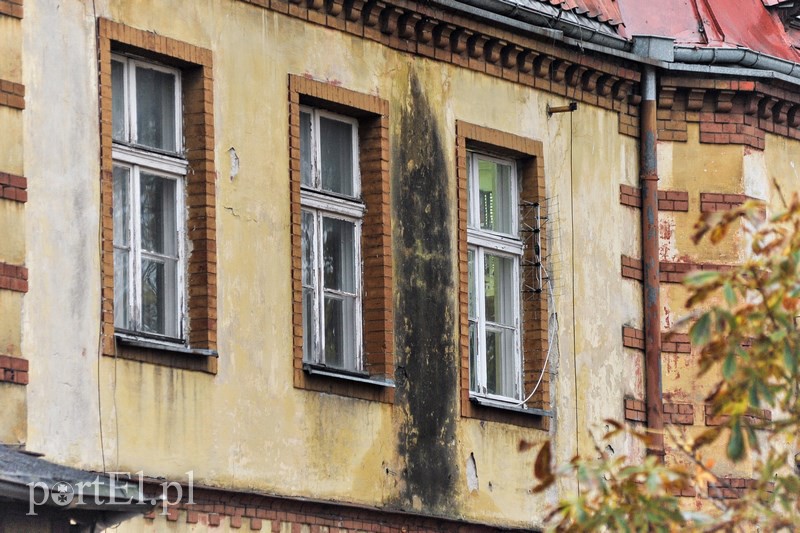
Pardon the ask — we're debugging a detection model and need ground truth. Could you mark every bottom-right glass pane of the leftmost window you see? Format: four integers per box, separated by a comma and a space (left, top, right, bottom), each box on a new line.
142, 258, 178, 337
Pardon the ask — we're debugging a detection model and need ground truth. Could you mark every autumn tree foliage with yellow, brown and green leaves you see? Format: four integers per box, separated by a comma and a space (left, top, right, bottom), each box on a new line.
534, 196, 800, 531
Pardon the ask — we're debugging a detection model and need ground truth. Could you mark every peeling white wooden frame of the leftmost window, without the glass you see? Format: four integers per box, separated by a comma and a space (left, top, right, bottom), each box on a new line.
112, 54, 189, 345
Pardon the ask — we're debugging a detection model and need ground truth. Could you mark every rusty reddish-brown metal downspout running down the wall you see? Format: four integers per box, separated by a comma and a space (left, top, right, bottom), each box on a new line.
639, 66, 664, 461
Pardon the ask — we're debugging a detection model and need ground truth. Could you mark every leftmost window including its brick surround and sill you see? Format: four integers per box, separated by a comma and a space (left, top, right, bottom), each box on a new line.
97, 18, 217, 374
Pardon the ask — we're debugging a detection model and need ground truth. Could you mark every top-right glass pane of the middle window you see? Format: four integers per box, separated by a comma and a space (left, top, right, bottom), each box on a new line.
319, 117, 354, 196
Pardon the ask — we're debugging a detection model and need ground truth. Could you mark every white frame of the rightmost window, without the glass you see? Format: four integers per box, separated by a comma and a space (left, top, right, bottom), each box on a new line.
467, 151, 524, 403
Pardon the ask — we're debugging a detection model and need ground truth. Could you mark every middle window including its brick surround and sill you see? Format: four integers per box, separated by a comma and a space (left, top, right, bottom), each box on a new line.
288, 74, 394, 403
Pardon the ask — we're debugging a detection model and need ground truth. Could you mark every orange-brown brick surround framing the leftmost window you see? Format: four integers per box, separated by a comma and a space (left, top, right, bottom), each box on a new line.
97, 18, 217, 374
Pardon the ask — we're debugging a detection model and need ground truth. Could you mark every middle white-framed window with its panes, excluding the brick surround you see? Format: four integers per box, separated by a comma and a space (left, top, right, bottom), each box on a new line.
300, 107, 364, 372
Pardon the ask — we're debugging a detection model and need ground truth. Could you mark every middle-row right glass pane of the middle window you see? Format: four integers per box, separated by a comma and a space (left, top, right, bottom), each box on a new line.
322, 217, 356, 290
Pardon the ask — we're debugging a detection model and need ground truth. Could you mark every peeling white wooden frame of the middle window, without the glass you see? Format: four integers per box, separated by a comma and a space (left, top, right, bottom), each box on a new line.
300, 106, 366, 372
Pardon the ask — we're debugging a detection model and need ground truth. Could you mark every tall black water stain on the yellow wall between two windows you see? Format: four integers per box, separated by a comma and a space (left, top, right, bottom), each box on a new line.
392, 74, 458, 511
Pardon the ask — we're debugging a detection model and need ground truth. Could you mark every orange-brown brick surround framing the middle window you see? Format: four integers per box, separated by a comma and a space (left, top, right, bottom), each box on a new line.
289, 75, 394, 403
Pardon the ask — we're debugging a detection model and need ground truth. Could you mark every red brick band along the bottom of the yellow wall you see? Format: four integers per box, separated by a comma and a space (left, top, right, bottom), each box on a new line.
137, 480, 530, 533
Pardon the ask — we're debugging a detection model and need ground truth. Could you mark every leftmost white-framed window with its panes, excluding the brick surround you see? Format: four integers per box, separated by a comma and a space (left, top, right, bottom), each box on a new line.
111, 56, 188, 340
